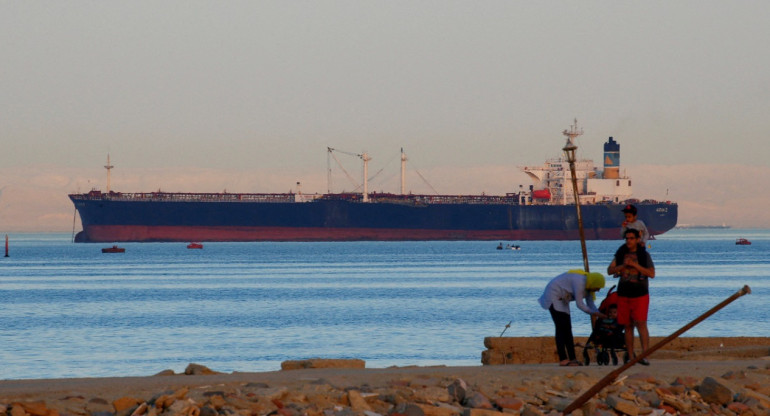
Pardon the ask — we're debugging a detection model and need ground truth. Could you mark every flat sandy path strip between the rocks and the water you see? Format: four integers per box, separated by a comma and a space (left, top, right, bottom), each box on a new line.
0, 338, 770, 404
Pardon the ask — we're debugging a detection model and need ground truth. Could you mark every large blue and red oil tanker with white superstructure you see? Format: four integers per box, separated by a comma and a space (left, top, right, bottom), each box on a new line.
69, 122, 678, 242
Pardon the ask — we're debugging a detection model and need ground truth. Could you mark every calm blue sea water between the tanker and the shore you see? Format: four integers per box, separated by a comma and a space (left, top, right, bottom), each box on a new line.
0, 229, 770, 379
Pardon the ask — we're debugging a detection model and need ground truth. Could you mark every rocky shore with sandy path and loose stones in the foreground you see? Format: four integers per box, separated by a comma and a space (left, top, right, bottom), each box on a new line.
0, 338, 770, 416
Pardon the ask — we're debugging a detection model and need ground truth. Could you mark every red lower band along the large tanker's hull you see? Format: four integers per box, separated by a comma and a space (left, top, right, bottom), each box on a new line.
84, 225, 620, 242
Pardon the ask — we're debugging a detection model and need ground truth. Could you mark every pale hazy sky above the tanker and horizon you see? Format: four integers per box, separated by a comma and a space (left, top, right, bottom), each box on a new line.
0, 0, 770, 232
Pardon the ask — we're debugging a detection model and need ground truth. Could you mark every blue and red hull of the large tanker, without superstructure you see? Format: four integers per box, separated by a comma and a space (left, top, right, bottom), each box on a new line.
70, 195, 678, 242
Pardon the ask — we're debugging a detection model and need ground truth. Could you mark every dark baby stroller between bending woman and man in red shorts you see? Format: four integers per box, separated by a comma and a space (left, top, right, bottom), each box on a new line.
583, 286, 626, 365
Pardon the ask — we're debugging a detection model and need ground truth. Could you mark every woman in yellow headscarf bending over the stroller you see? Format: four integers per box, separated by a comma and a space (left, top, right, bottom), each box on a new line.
538, 270, 605, 366
